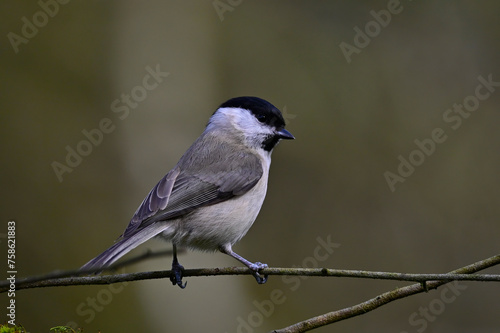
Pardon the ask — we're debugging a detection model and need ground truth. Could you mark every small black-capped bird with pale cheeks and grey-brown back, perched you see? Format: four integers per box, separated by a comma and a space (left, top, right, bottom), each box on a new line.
81, 97, 294, 288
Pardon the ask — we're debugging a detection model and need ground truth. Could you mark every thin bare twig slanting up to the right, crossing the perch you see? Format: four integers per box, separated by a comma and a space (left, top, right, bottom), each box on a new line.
272, 255, 500, 333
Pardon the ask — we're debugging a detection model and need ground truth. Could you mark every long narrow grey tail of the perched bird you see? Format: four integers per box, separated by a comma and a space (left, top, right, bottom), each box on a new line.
80, 222, 169, 270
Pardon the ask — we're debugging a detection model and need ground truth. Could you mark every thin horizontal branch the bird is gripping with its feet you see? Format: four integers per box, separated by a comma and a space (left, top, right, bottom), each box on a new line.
0, 252, 500, 293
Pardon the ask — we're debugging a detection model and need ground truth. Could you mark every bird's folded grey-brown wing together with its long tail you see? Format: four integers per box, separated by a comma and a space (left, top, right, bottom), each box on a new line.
82, 147, 263, 270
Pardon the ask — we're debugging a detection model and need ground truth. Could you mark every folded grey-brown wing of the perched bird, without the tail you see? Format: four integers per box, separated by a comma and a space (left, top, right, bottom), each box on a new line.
123, 151, 263, 233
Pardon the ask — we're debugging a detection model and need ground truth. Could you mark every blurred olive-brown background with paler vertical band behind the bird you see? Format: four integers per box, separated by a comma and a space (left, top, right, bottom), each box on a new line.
0, 0, 500, 333
